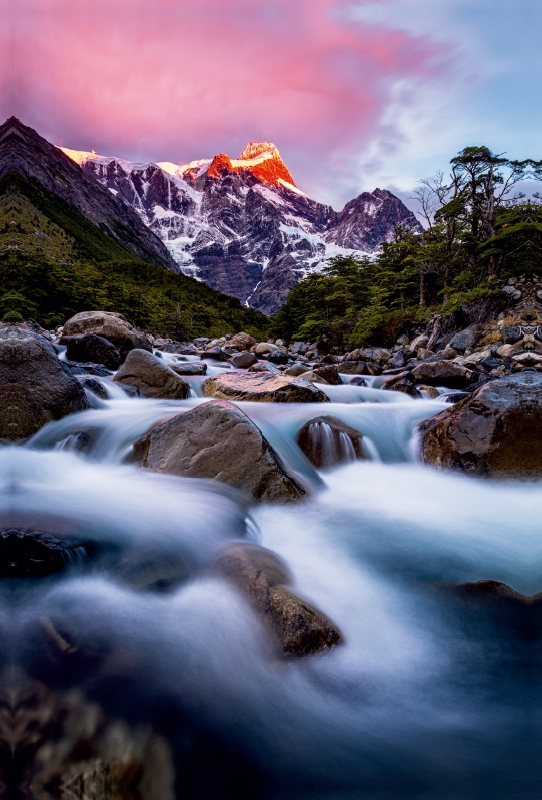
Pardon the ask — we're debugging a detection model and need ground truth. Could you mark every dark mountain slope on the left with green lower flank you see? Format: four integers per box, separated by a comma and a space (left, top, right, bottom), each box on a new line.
0, 118, 268, 339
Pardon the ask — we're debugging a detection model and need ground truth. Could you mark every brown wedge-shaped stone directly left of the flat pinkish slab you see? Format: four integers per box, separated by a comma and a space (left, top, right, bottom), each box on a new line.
113, 350, 190, 400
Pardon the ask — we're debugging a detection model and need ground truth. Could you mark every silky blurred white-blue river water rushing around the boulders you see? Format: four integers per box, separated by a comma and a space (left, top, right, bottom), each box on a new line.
0, 378, 542, 800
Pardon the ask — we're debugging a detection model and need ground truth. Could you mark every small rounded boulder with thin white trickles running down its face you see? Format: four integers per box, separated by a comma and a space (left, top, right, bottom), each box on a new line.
297, 416, 366, 469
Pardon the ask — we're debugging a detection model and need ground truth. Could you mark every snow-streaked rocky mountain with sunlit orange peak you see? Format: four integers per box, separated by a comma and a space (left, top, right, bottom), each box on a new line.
62, 142, 421, 314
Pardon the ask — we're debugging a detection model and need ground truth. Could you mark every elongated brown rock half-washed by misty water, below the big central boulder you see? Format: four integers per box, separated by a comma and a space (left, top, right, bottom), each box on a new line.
213, 544, 342, 656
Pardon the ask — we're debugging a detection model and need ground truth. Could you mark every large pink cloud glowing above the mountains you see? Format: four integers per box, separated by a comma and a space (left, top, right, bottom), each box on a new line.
0, 0, 452, 203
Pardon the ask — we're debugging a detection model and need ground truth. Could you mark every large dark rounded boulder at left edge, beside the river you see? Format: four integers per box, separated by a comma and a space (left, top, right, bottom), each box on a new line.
0, 323, 90, 442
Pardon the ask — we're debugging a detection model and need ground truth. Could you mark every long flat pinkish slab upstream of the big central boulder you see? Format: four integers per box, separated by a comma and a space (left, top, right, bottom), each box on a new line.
202, 372, 329, 403
